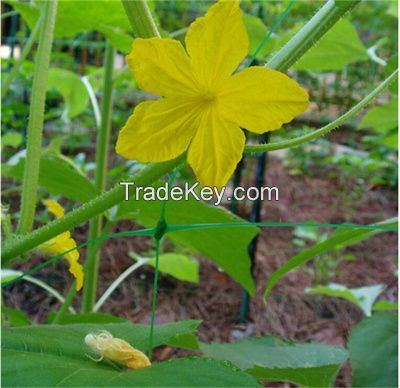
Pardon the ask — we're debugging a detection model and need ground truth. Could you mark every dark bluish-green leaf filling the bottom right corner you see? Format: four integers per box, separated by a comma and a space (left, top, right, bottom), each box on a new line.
348, 313, 398, 387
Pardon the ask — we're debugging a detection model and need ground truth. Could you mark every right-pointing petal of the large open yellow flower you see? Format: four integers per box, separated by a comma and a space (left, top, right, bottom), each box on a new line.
219, 66, 308, 133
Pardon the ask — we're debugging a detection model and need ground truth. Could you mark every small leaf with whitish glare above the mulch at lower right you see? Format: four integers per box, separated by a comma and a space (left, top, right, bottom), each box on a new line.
306, 283, 385, 317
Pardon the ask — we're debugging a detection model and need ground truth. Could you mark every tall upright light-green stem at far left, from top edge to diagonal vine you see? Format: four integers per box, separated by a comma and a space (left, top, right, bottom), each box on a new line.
17, 0, 57, 234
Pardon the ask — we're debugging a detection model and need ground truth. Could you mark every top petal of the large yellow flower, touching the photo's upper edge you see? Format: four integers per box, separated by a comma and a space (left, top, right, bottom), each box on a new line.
185, 0, 249, 86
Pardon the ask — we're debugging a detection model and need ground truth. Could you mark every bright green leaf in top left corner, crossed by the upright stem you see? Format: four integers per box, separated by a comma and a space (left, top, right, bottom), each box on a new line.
9, 0, 133, 53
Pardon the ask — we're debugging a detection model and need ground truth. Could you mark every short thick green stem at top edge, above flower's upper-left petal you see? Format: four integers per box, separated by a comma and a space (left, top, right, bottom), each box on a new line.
122, 0, 160, 38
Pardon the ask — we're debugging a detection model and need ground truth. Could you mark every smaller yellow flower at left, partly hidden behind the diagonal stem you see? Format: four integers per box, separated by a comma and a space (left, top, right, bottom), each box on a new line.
40, 200, 83, 291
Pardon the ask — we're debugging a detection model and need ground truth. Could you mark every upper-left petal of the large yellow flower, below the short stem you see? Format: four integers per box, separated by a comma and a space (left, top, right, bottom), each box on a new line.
126, 38, 196, 96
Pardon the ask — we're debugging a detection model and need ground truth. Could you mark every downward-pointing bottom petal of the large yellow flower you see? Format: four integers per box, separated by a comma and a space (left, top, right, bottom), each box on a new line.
188, 108, 245, 188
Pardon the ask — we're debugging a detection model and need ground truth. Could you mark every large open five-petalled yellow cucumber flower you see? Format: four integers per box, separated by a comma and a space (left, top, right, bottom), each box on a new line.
116, 1, 308, 187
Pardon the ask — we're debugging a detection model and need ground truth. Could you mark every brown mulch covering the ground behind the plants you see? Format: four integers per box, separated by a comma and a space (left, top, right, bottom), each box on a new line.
4, 159, 397, 387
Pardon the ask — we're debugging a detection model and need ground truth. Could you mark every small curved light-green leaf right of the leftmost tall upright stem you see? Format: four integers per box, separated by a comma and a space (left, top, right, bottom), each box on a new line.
47, 67, 89, 119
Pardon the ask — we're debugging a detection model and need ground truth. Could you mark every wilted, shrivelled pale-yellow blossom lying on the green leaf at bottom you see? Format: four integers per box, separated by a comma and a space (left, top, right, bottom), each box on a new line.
85, 330, 151, 369
